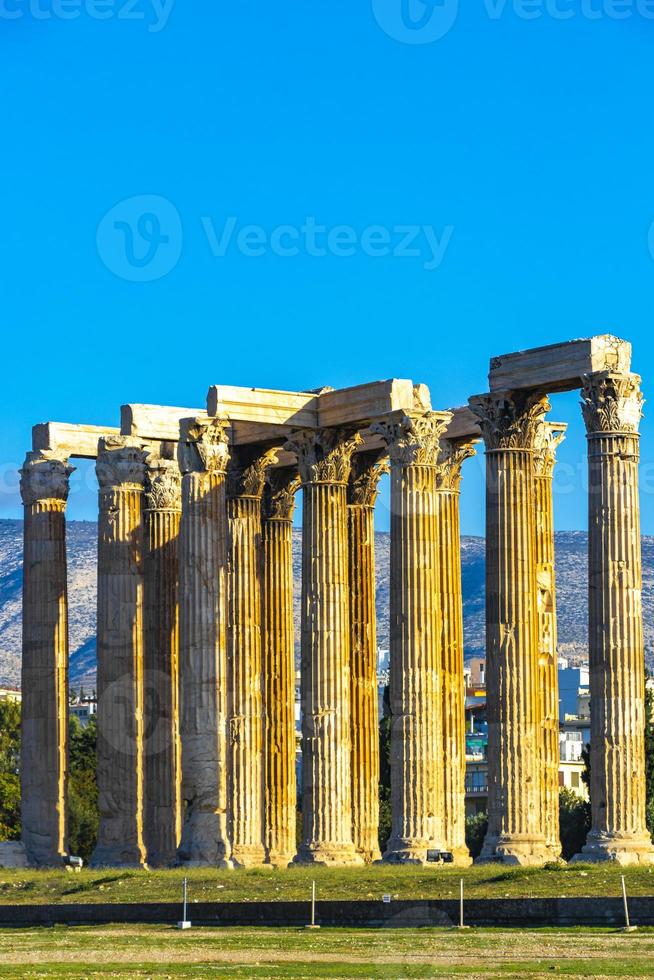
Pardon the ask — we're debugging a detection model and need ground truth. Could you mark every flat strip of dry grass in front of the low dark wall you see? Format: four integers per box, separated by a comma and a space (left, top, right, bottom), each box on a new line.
0, 926, 654, 980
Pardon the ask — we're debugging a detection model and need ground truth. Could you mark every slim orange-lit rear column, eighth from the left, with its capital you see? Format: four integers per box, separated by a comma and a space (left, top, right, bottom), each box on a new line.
348, 451, 388, 864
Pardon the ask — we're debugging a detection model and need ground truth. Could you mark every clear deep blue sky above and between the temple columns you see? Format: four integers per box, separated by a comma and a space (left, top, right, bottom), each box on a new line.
0, 0, 654, 534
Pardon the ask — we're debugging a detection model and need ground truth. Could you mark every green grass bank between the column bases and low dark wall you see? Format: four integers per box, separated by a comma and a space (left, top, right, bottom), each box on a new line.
0, 865, 654, 905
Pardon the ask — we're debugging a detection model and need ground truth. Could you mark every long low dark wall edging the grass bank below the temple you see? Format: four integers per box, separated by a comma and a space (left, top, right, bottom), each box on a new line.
0, 897, 654, 928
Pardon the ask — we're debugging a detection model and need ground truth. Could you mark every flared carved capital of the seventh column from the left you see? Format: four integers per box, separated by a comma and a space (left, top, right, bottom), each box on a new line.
285, 427, 363, 484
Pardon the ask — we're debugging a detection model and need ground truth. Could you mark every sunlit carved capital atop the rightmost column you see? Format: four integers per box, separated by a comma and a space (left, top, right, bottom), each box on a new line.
581, 371, 643, 436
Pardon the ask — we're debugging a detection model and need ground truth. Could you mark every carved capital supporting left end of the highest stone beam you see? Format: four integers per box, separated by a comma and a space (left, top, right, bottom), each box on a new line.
469, 391, 551, 452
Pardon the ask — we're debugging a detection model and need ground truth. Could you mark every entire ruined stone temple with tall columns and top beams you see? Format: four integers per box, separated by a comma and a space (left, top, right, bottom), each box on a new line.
14, 336, 654, 868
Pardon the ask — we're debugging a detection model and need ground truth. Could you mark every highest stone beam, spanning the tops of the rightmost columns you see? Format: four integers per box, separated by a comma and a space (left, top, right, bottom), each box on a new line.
488, 334, 631, 392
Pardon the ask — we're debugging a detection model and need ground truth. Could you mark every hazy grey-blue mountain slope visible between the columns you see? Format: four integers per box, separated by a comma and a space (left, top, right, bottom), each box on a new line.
0, 520, 654, 689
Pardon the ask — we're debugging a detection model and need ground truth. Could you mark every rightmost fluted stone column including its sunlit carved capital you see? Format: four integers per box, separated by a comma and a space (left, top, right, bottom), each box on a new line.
577, 373, 654, 864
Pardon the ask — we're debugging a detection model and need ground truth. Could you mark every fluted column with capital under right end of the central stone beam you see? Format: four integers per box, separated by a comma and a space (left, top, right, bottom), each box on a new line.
374, 412, 451, 864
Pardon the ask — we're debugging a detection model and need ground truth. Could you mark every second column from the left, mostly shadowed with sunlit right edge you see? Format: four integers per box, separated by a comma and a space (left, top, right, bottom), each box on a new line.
92, 437, 145, 867
